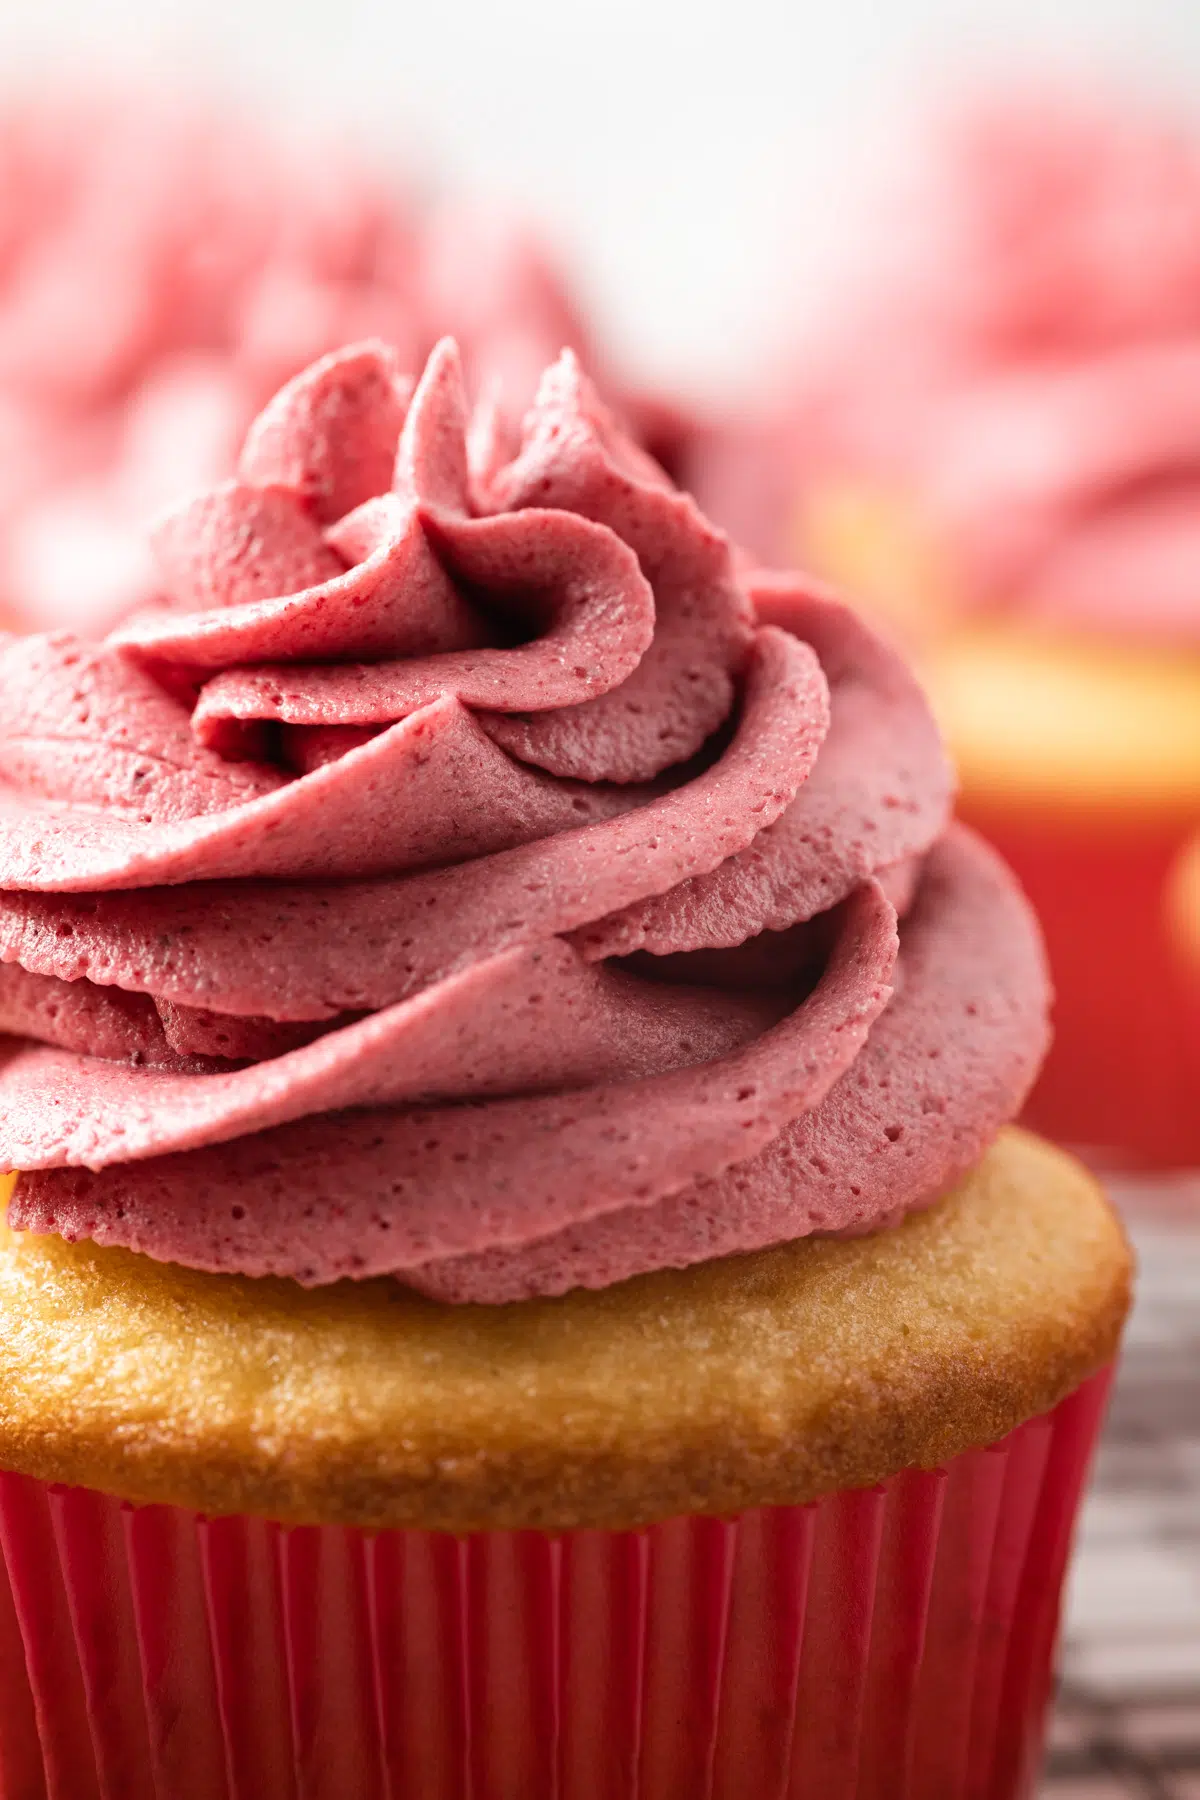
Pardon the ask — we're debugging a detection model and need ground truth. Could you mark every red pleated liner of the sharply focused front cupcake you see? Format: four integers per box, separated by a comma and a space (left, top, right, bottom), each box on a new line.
0, 1372, 1108, 1800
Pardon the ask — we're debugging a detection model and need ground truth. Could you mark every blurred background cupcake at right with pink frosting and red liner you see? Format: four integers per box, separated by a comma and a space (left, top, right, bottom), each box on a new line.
707, 92, 1200, 1166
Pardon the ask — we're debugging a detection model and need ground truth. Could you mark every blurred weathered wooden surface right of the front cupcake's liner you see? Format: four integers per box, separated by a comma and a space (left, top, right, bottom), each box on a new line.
1042, 1175, 1200, 1800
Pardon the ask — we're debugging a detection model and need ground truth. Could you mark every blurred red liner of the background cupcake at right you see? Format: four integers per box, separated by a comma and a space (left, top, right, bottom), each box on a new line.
959, 797, 1200, 1170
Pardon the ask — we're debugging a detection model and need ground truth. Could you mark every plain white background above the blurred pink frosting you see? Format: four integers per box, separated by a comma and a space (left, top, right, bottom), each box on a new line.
0, 0, 1200, 389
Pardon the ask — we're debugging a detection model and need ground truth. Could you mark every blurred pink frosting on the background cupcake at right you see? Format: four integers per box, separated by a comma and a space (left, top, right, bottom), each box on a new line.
700, 88, 1200, 641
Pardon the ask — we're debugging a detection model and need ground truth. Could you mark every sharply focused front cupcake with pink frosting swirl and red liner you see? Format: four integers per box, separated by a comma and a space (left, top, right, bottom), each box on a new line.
0, 342, 1130, 1800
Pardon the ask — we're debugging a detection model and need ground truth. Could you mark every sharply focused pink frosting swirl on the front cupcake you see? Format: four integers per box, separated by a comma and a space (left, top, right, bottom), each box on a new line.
0, 342, 1047, 1301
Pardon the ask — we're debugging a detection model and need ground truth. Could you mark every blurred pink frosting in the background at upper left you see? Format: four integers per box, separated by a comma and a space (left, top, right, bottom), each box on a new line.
0, 90, 600, 632
